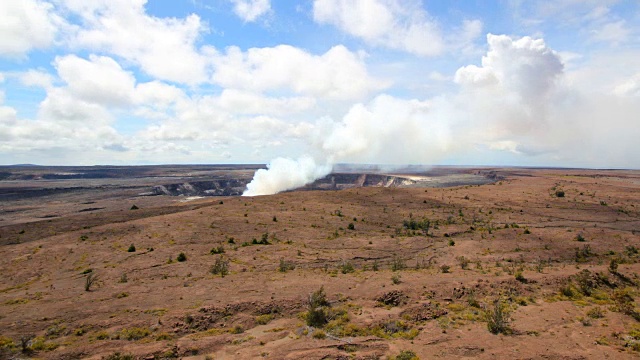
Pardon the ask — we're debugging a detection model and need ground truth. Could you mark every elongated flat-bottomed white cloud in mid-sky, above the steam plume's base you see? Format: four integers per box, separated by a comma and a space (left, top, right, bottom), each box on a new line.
213, 45, 384, 100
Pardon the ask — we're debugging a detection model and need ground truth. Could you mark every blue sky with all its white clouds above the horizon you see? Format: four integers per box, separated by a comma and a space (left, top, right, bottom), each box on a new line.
0, 0, 640, 168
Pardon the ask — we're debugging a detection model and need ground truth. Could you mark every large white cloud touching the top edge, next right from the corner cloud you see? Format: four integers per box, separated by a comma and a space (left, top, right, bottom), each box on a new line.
64, 0, 209, 84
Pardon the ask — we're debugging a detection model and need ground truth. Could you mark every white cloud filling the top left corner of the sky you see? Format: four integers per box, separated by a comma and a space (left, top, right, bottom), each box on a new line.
0, 0, 61, 57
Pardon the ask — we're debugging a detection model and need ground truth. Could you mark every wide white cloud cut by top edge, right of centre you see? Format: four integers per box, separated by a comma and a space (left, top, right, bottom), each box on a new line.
313, 0, 445, 56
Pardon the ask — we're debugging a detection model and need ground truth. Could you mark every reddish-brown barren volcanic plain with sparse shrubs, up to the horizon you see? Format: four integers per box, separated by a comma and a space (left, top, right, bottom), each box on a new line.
0, 166, 640, 360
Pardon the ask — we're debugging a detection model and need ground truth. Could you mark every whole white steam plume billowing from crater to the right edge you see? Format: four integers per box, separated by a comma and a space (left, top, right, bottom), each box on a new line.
245, 34, 640, 195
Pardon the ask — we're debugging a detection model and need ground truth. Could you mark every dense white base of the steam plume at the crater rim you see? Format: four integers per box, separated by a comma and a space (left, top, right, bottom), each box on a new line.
242, 156, 331, 196
